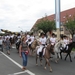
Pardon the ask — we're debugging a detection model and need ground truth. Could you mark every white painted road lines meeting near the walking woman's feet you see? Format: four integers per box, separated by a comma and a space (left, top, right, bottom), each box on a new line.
0, 51, 35, 75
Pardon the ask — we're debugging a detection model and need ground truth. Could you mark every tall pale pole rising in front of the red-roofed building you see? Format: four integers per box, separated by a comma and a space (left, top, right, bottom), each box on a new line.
55, 0, 60, 40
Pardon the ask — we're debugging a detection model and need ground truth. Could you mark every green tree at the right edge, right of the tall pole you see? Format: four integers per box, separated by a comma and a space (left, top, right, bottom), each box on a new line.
64, 16, 75, 37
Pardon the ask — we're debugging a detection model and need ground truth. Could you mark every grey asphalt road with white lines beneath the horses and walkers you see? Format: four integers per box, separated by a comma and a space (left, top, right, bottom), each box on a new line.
0, 45, 75, 75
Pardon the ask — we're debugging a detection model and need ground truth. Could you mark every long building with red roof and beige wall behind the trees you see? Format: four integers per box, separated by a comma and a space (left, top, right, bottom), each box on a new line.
31, 7, 75, 36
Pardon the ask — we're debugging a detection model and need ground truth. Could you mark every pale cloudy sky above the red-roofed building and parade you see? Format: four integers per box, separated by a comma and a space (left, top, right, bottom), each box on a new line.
0, 0, 75, 32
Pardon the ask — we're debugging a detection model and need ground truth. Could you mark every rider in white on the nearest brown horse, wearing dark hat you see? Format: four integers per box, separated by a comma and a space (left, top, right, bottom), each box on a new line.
37, 32, 47, 57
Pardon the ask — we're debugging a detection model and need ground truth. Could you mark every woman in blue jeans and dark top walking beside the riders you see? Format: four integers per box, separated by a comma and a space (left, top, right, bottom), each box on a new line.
19, 36, 29, 71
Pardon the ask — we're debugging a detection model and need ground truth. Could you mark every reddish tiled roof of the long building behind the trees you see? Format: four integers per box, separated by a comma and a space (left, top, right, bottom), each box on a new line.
32, 7, 75, 29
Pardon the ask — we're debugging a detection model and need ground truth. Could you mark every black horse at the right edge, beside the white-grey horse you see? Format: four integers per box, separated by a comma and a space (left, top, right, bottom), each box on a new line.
60, 42, 75, 62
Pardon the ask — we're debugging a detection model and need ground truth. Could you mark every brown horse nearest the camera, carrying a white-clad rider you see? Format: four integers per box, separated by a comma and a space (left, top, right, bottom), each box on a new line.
36, 44, 54, 72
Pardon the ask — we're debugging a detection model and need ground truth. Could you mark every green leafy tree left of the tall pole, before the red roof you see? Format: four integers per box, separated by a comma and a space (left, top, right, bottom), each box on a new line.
35, 18, 56, 33
